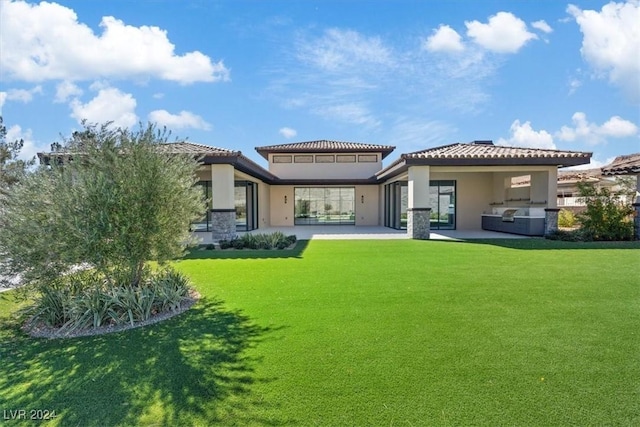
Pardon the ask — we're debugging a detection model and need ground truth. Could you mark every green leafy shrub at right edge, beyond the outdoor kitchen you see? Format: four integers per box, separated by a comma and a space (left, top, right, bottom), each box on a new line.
577, 182, 633, 240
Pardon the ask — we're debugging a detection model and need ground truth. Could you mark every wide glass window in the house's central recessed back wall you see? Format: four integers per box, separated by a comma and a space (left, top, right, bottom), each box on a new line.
294, 187, 356, 225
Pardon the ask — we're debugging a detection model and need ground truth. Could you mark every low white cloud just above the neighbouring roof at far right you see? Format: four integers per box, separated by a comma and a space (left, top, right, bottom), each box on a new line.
556, 111, 638, 145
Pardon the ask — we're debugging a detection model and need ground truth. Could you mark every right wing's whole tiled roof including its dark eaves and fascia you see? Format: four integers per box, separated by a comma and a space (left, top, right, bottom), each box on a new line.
376, 141, 592, 179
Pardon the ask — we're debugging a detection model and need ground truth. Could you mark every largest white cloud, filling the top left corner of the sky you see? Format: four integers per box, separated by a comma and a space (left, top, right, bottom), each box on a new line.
0, 1, 229, 84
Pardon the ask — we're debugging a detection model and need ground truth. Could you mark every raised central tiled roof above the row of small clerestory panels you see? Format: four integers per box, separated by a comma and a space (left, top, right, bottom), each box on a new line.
256, 139, 396, 160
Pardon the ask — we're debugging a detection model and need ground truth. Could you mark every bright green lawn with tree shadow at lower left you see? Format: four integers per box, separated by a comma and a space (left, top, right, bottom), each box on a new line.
0, 239, 640, 426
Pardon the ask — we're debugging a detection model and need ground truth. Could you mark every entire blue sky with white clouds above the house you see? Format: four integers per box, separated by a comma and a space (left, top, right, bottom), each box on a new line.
0, 0, 640, 170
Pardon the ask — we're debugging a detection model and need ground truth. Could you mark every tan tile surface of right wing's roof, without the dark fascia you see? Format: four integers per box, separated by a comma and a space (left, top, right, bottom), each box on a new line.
402, 141, 591, 159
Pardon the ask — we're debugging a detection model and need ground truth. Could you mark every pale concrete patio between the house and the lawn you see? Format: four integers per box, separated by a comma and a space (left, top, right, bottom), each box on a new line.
195, 225, 527, 244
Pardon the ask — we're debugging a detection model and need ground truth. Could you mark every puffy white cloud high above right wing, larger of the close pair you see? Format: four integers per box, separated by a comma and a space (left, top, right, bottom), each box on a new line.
465, 12, 538, 53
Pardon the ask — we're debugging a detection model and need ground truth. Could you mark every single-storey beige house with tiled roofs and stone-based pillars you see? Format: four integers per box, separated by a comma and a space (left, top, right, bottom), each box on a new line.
163, 140, 591, 240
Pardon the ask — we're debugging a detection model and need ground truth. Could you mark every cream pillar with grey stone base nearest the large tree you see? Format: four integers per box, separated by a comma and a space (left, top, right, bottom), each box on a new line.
211, 164, 236, 242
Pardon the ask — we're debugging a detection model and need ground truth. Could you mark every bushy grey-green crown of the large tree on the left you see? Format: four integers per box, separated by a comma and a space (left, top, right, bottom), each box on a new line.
0, 124, 204, 286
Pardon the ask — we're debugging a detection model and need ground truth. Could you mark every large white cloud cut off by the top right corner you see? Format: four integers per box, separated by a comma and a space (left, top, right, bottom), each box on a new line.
567, 1, 640, 101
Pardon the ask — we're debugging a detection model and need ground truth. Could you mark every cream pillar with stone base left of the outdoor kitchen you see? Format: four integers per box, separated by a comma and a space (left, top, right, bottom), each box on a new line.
407, 166, 431, 240
